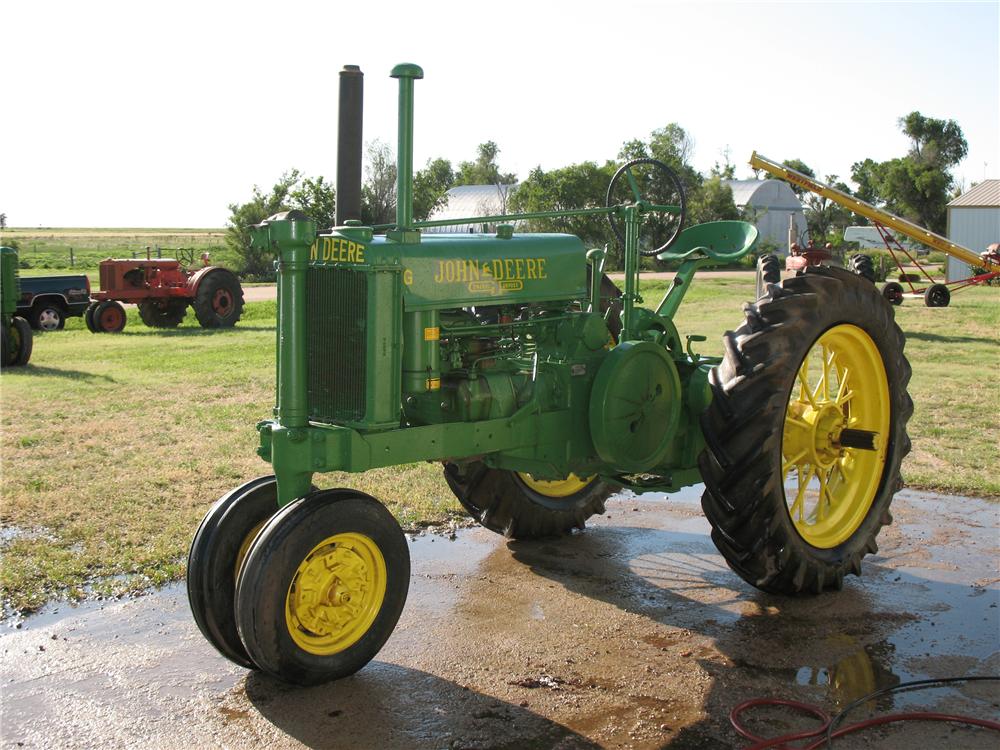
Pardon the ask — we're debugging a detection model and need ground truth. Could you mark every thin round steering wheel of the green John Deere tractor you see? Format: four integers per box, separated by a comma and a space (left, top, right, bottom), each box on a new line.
606, 159, 687, 256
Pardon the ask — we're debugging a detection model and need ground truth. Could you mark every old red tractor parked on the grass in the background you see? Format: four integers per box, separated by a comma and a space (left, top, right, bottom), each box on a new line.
84, 251, 243, 333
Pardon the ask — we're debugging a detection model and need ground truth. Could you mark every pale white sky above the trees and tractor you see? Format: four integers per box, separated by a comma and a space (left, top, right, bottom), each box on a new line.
0, 0, 1000, 227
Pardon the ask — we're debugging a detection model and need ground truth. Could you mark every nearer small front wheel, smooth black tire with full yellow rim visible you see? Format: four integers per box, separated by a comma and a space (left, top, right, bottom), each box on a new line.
236, 489, 410, 685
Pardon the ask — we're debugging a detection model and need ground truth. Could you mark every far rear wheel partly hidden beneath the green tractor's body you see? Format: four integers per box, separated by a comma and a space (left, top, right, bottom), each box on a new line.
444, 462, 612, 539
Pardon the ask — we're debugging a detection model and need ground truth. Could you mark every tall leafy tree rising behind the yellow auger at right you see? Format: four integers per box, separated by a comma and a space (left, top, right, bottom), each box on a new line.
851, 112, 968, 233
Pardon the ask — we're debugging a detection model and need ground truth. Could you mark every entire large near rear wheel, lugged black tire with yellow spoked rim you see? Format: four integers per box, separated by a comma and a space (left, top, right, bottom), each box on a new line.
699, 266, 913, 594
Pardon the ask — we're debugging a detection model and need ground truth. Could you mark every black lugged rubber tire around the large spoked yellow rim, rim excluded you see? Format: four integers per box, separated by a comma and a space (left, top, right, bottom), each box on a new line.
699, 266, 913, 595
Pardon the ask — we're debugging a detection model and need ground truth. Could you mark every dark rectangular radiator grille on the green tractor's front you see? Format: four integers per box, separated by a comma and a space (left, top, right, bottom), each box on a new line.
306, 266, 368, 422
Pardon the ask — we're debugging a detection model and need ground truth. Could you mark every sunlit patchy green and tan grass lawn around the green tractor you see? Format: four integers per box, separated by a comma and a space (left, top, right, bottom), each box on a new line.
0, 278, 1000, 610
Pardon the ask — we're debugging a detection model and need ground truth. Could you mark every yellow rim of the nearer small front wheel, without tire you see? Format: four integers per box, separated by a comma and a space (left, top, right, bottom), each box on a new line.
285, 532, 386, 656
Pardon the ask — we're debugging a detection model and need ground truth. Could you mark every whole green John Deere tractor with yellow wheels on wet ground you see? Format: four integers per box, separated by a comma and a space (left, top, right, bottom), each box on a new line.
187, 64, 912, 684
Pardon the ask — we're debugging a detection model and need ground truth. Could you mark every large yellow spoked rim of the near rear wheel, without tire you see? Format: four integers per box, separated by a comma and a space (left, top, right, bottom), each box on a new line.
781, 323, 890, 549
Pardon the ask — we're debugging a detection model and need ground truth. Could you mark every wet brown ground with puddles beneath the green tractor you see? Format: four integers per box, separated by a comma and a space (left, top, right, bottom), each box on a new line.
0, 492, 1000, 750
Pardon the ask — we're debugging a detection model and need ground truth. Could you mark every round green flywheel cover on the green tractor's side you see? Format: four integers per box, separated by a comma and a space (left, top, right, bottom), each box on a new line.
589, 341, 681, 472
